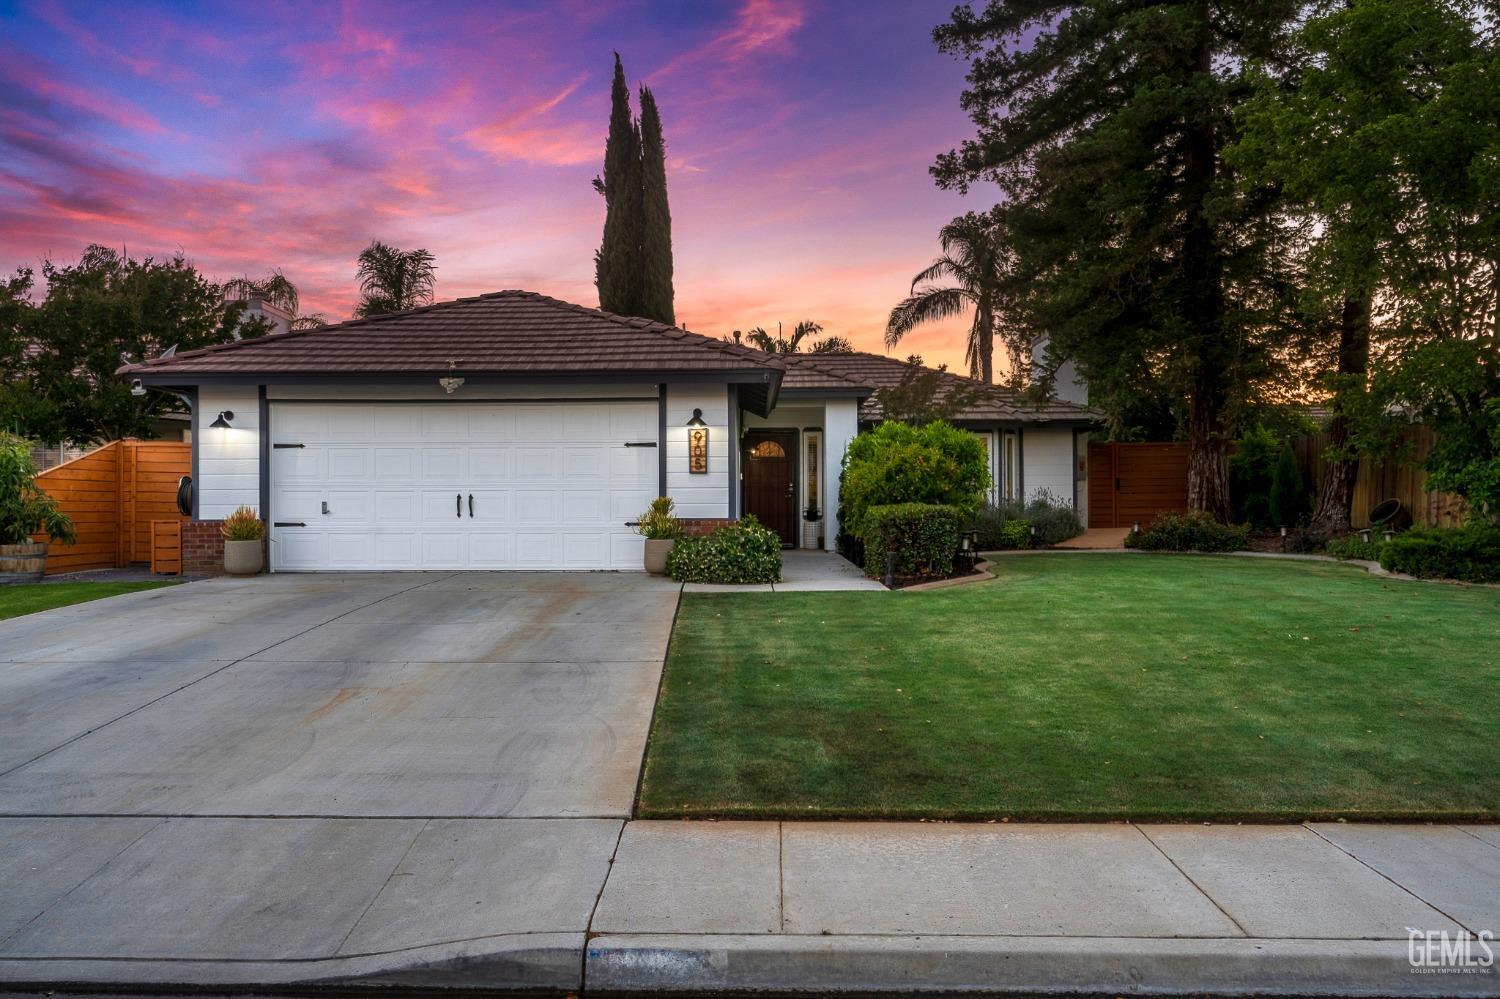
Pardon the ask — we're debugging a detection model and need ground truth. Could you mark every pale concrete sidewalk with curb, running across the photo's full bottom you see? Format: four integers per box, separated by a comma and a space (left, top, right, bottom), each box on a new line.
0, 818, 1500, 996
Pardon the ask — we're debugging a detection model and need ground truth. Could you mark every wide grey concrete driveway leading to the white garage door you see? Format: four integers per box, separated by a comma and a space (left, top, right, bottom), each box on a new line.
0, 573, 678, 984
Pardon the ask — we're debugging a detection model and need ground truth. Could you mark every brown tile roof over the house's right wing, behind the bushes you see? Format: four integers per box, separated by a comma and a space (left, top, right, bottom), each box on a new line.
777, 351, 1103, 423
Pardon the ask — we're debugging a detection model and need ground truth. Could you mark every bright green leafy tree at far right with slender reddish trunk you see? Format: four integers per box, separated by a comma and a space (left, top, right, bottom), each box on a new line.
1227, 0, 1500, 534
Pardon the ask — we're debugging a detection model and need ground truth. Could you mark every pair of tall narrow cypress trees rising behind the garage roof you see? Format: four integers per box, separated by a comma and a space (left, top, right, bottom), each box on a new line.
594, 53, 677, 324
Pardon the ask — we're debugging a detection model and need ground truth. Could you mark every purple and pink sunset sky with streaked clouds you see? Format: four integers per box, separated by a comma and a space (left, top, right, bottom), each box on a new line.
0, 0, 995, 369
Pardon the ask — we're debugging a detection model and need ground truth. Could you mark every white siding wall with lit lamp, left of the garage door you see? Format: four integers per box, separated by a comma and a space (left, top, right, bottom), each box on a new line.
192, 386, 261, 521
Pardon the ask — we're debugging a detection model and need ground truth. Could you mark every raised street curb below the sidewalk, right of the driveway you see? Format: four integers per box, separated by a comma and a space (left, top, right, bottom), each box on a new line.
584, 935, 1500, 998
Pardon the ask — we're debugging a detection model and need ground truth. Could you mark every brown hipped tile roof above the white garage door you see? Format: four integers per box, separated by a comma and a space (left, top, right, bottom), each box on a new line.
119, 291, 785, 377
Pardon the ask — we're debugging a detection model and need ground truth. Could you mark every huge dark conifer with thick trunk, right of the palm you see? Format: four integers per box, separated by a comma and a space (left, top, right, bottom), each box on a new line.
933, 0, 1298, 518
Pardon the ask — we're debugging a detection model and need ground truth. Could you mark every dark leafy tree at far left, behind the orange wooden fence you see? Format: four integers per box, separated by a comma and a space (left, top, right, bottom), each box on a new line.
0, 246, 267, 446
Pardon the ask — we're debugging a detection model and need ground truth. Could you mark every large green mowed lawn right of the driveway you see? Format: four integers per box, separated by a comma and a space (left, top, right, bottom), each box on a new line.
639, 554, 1500, 821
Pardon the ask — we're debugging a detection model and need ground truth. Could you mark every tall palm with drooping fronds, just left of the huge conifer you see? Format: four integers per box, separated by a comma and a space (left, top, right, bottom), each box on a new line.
885, 212, 1010, 381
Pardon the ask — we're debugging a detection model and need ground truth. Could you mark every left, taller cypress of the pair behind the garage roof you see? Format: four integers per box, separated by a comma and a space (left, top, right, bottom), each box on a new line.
594, 53, 641, 315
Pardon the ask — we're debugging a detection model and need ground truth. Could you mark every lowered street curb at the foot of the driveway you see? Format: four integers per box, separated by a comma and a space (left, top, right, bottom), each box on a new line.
0, 933, 584, 993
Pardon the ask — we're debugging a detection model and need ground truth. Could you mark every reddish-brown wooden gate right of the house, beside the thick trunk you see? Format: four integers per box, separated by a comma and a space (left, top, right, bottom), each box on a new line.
1089, 443, 1188, 530
